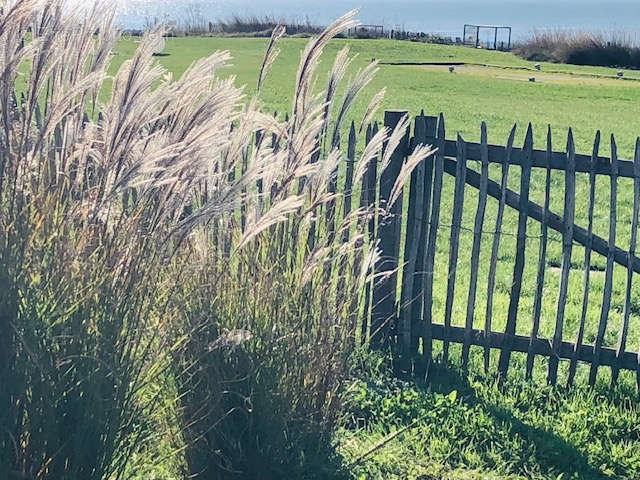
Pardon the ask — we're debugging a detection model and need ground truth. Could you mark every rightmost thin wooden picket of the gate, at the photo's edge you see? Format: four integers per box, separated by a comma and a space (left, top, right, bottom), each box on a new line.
611, 138, 640, 387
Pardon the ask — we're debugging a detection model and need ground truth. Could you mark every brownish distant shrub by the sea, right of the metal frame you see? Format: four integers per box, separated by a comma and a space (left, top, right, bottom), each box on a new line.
513, 31, 640, 68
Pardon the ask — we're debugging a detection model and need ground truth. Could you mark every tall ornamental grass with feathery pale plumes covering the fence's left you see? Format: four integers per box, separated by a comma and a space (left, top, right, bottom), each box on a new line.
0, 0, 399, 480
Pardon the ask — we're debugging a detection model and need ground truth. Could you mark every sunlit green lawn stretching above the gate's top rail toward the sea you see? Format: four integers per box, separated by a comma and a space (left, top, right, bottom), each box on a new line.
113, 37, 640, 157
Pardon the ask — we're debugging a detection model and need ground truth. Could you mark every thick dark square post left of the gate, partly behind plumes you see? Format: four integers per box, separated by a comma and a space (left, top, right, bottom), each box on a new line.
371, 110, 409, 347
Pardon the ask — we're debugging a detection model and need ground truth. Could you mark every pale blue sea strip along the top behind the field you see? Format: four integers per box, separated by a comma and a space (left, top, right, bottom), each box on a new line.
119, 0, 640, 40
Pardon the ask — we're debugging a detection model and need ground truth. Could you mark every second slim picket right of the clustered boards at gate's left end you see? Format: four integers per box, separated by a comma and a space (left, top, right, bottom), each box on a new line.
462, 122, 489, 368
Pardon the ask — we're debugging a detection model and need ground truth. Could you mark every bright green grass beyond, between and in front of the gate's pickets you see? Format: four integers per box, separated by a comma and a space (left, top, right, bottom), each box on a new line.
114, 38, 640, 478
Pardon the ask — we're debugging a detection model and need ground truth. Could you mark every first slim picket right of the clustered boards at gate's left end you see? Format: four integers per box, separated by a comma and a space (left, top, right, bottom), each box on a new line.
442, 134, 467, 362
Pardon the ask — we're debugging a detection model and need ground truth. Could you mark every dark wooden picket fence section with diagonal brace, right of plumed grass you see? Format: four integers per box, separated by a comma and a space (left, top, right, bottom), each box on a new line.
361, 111, 640, 387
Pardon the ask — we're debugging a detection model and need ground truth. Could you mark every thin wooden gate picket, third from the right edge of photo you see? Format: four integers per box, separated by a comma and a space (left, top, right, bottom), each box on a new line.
567, 131, 600, 387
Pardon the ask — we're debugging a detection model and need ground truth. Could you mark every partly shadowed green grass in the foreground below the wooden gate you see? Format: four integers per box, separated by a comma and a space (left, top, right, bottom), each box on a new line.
339, 360, 640, 479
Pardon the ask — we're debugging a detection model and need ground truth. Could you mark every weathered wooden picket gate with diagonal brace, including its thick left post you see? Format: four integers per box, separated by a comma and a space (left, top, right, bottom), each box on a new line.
363, 111, 640, 387
